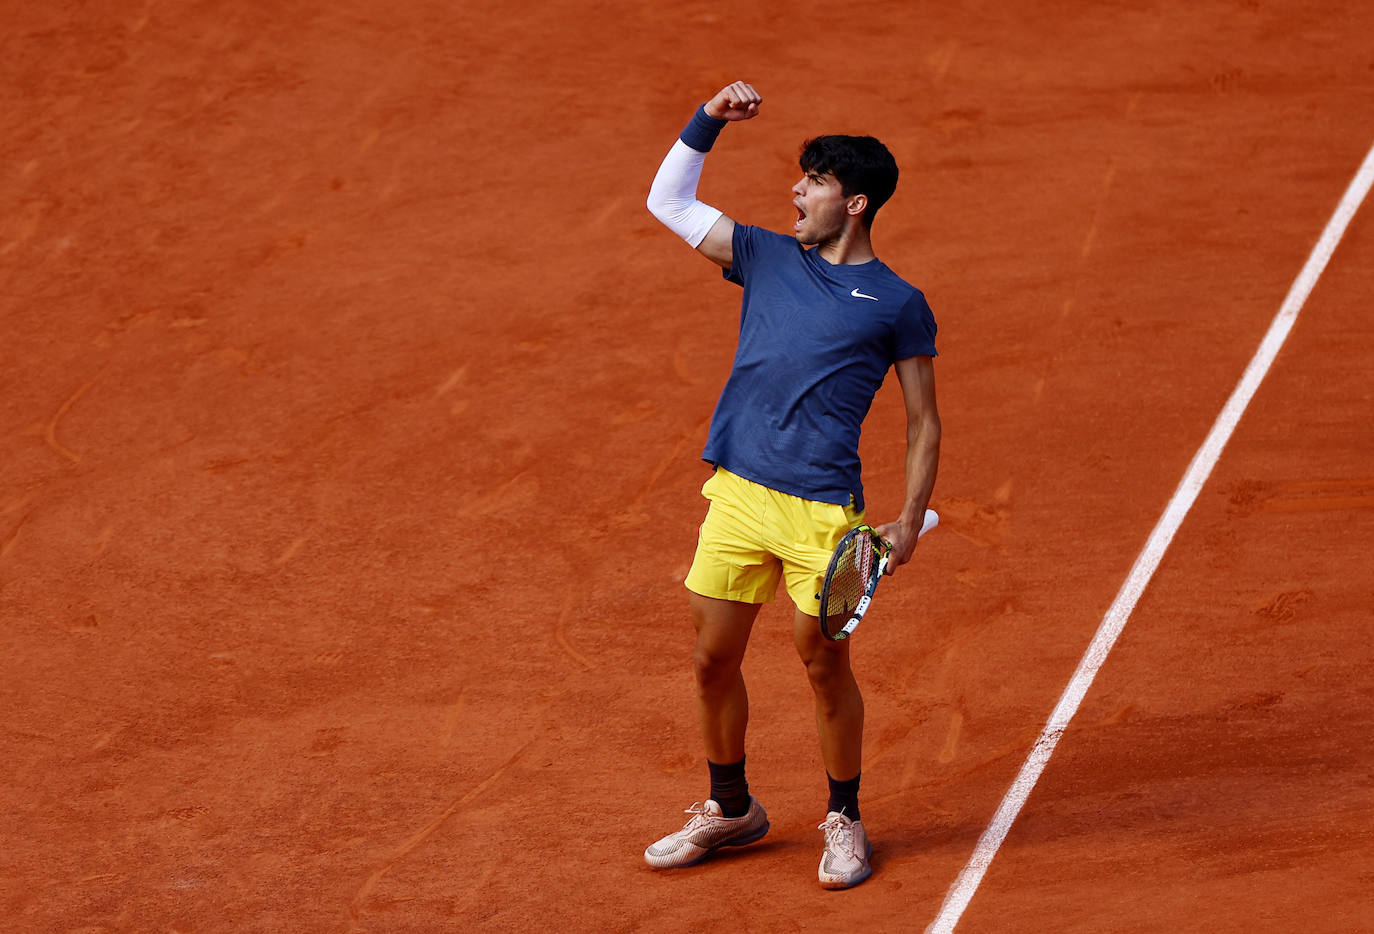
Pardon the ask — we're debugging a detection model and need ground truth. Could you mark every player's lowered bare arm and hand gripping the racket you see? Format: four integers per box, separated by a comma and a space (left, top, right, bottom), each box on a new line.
877, 357, 940, 574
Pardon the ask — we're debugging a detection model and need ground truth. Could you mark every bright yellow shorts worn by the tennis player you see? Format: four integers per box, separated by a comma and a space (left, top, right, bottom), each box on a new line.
684, 468, 863, 615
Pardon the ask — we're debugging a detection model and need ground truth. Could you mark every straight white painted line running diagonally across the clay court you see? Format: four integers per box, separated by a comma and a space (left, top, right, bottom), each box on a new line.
926, 140, 1374, 934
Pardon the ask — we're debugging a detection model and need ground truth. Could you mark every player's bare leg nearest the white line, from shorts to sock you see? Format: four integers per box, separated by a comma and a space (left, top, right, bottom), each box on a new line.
791, 610, 863, 780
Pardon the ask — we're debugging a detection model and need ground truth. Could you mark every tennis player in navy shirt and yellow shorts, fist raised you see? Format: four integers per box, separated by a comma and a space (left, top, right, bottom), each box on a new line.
644, 81, 940, 889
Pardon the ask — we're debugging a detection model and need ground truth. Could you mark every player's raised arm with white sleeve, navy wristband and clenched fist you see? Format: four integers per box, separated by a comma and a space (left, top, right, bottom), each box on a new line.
647, 81, 763, 269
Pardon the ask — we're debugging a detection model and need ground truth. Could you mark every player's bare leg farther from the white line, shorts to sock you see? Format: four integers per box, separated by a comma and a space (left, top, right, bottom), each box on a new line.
690, 593, 758, 762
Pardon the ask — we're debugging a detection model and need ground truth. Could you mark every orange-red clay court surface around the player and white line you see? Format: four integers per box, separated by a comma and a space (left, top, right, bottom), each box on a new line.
0, 0, 1374, 934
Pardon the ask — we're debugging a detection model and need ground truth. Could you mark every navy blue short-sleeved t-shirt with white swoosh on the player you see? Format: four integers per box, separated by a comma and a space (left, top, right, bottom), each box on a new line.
702, 224, 936, 510
